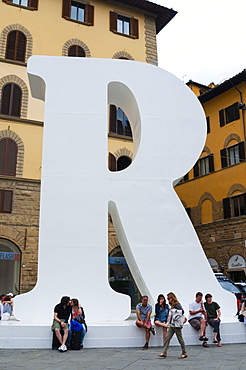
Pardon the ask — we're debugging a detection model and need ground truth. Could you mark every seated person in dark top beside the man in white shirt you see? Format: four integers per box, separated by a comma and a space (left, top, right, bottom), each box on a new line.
204, 293, 222, 347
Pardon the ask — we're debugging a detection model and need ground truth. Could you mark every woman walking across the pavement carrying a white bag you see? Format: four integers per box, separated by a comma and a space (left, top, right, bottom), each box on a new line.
158, 292, 188, 358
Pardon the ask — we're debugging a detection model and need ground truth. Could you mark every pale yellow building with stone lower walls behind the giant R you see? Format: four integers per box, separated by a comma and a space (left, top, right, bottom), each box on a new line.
0, 0, 176, 300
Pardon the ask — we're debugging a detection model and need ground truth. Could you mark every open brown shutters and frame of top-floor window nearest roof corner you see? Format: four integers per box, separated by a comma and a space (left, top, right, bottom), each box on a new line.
109, 11, 139, 39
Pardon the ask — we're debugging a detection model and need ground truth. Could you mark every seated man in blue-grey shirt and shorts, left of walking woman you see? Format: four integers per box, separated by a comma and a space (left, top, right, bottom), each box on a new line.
135, 295, 155, 349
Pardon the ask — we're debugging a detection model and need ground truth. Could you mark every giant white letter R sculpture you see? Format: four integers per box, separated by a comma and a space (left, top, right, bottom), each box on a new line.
15, 56, 235, 323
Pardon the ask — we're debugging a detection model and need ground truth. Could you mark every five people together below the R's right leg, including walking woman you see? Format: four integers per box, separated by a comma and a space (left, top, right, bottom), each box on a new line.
136, 292, 222, 359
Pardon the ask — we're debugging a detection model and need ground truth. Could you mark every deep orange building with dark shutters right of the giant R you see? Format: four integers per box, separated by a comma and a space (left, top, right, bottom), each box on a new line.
175, 70, 246, 281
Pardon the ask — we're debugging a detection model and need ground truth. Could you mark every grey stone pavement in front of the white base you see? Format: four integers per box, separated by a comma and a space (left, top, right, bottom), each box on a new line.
0, 344, 246, 370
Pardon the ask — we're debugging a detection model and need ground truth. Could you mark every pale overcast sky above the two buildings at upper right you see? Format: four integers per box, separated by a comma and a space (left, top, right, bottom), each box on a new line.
156, 0, 246, 85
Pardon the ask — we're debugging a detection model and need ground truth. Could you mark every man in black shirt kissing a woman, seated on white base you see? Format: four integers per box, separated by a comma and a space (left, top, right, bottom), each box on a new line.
52, 296, 72, 352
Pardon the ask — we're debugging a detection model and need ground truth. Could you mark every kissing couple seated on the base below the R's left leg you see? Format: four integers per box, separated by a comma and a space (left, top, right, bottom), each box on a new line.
51, 296, 87, 352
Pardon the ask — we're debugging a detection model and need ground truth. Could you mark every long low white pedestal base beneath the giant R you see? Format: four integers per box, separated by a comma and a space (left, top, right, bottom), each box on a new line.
0, 317, 246, 349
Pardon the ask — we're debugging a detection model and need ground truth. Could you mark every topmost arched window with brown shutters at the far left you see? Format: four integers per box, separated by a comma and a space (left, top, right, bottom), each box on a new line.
5, 31, 26, 62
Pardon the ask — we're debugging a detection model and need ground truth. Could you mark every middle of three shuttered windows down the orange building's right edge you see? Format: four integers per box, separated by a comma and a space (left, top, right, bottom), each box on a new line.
220, 141, 245, 168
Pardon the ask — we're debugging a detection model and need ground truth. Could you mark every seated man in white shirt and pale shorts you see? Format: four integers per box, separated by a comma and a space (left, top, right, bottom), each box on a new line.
188, 292, 209, 347
